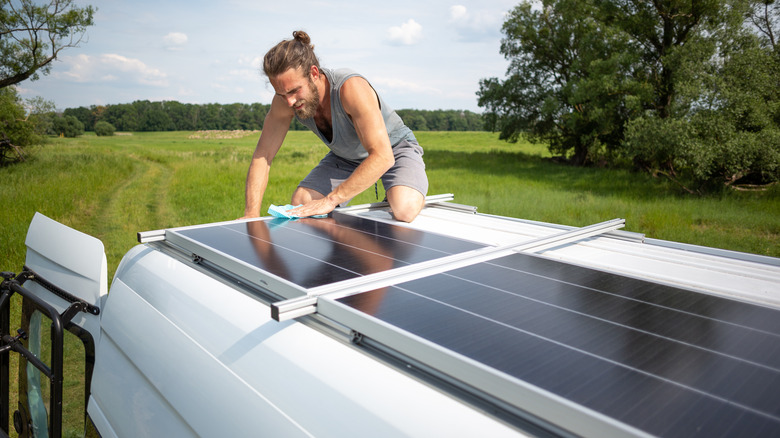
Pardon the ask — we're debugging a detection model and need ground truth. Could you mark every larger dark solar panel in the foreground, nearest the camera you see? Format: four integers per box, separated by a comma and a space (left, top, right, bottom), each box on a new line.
337, 254, 780, 437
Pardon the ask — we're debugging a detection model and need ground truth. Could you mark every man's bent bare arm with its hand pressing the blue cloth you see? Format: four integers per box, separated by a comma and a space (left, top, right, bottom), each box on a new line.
290, 77, 395, 216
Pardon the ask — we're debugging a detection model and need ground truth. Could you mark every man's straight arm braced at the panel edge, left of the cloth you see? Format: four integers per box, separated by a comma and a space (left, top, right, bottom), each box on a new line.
241, 96, 293, 219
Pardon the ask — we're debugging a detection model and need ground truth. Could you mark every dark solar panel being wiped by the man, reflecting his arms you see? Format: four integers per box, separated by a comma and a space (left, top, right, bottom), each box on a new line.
174, 214, 483, 289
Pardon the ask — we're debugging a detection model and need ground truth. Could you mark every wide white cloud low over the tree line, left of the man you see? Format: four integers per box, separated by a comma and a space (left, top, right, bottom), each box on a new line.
54, 53, 168, 87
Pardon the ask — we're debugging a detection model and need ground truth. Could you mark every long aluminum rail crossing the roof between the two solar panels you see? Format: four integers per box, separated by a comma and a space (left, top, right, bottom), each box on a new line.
271, 219, 626, 321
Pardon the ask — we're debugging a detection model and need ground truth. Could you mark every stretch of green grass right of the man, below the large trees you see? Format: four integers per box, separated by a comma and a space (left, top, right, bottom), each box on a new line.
418, 133, 780, 257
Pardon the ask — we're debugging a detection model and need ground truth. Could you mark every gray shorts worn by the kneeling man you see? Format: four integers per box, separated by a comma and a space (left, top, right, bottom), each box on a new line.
298, 140, 428, 204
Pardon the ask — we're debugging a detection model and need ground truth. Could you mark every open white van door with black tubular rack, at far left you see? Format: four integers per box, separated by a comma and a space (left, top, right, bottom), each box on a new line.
0, 213, 108, 437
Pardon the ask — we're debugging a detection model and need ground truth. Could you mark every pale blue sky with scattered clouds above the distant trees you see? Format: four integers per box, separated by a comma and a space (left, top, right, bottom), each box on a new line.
18, 0, 519, 112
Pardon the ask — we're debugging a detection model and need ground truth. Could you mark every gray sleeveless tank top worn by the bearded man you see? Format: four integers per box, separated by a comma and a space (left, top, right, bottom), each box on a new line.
296, 68, 417, 161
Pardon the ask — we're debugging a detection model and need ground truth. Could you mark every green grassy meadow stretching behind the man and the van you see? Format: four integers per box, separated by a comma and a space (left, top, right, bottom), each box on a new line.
0, 132, 780, 436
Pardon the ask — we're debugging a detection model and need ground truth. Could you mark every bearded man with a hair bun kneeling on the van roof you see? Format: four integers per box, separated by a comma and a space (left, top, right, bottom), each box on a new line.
244, 31, 428, 222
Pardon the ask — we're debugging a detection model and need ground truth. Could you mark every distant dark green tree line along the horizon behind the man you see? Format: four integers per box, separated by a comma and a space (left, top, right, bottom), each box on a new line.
61, 100, 484, 134
